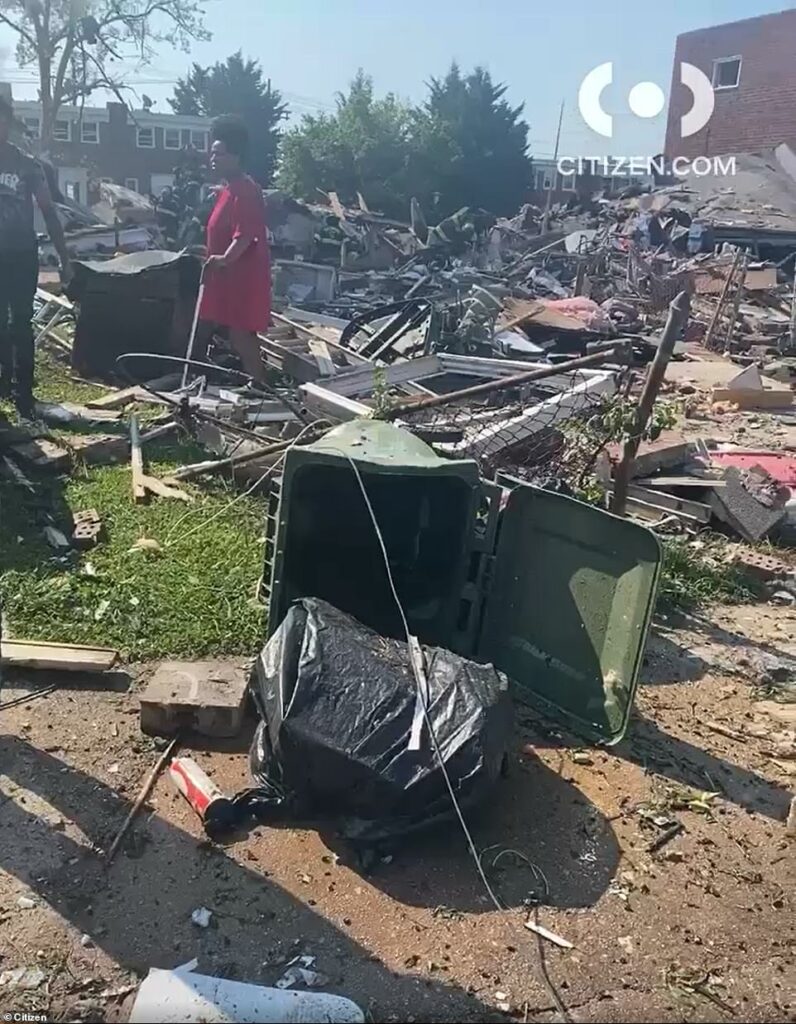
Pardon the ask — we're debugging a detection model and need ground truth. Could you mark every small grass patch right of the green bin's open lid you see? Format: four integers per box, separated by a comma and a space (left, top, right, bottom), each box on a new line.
658, 535, 760, 611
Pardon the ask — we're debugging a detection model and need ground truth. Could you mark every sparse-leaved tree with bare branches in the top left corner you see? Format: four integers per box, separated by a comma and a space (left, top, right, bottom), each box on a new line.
0, 0, 210, 151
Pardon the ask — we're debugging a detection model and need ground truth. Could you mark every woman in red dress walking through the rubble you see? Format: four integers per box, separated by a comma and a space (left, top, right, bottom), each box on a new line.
200, 118, 270, 380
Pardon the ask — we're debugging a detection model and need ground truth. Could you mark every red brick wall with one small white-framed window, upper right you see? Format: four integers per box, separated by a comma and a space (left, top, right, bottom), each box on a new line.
666, 10, 796, 159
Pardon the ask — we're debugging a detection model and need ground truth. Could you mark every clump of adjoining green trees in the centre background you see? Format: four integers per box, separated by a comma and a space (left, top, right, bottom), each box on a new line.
279, 65, 532, 223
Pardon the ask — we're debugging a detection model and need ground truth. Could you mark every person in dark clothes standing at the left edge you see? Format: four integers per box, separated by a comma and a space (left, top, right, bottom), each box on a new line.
0, 96, 71, 417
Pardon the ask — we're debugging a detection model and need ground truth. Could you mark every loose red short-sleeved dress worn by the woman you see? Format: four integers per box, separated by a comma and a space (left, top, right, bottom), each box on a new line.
200, 175, 270, 332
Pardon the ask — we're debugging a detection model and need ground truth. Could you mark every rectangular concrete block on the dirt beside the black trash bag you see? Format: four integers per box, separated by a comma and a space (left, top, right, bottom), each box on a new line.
140, 660, 249, 736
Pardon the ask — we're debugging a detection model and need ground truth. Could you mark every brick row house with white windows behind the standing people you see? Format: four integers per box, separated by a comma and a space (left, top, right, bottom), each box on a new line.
6, 92, 210, 203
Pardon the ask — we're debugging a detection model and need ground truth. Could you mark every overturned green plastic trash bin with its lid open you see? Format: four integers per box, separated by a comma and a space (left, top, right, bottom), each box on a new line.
263, 420, 661, 742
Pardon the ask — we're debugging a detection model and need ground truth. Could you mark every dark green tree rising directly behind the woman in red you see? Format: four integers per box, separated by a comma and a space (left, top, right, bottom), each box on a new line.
169, 50, 288, 185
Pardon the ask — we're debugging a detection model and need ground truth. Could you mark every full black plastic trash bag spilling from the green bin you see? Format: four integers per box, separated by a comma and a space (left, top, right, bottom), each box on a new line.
248, 598, 512, 846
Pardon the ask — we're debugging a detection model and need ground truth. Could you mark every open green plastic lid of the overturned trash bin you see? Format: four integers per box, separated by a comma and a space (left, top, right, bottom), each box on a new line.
479, 484, 661, 743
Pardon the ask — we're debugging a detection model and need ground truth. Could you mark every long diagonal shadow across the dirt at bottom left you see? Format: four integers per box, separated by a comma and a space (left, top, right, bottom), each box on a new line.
0, 736, 510, 1021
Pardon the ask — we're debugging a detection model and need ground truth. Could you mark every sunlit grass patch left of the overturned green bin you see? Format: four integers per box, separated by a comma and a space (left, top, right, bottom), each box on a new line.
0, 353, 264, 660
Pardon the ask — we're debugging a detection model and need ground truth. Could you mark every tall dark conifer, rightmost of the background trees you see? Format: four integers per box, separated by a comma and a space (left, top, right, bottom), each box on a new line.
412, 63, 532, 215
